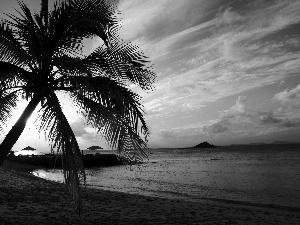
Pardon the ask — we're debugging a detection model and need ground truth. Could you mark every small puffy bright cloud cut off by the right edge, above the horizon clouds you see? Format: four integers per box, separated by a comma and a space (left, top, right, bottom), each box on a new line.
273, 84, 300, 109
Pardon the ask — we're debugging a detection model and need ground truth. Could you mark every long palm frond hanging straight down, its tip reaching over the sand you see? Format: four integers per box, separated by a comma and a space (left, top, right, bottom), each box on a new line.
39, 92, 85, 213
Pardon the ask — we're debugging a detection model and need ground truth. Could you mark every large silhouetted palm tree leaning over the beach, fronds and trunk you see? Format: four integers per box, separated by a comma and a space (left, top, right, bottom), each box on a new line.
0, 0, 155, 214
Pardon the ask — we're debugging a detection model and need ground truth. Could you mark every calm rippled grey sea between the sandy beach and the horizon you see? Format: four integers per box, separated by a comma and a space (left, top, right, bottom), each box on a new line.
34, 144, 300, 209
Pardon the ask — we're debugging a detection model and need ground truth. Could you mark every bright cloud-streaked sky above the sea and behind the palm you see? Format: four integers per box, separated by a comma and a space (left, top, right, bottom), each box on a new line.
0, 0, 300, 151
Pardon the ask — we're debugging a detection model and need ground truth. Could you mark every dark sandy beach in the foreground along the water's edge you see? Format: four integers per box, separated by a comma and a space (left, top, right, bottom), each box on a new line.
0, 162, 300, 225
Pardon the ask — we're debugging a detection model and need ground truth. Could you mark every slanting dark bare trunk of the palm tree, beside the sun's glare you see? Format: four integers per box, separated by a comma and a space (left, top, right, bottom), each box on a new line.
0, 95, 40, 165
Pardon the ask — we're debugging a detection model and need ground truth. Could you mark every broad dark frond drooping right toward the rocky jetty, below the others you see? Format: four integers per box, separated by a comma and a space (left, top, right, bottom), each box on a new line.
70, 77, 149, 161
